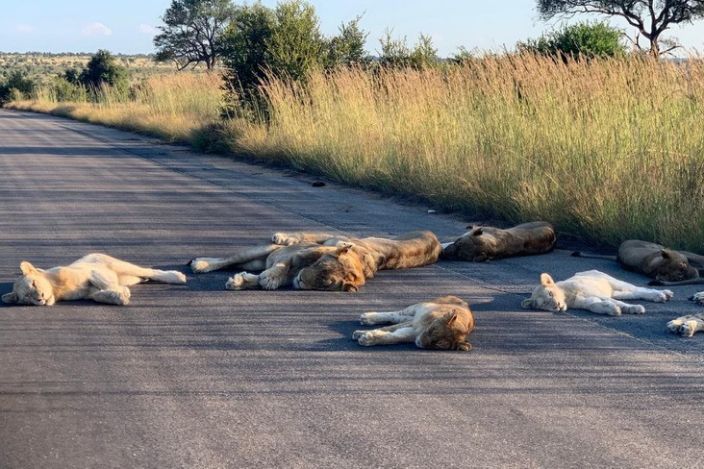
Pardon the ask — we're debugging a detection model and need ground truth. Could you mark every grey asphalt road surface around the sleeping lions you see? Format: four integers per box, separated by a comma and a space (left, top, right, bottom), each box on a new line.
0, 111, 704, 469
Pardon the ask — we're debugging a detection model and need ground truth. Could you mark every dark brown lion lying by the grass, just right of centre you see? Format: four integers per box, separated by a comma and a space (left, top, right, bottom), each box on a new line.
442, 221, 557, 262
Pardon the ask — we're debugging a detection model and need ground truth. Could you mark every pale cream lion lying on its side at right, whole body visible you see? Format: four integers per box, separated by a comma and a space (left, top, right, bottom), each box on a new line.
521, 270, 674, 316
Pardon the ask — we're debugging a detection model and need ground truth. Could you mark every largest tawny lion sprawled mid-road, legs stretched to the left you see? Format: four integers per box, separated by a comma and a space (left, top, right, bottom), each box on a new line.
191, 231, 442, 291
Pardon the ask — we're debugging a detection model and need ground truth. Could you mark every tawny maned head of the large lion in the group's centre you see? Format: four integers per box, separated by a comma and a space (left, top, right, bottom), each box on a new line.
293, 245, 366, 292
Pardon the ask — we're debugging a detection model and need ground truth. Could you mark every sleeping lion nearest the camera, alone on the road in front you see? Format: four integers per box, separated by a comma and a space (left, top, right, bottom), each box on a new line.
352, 296, 474, 352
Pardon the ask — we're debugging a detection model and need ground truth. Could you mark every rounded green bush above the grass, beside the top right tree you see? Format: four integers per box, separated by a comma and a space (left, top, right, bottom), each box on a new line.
518, 23, 626, 59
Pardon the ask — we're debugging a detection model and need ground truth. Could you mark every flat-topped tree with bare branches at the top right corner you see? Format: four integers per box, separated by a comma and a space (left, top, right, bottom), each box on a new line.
538, 0, 704, 57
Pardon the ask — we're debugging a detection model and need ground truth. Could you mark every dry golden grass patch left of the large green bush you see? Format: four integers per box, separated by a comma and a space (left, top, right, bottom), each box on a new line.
8, 73, 222, 142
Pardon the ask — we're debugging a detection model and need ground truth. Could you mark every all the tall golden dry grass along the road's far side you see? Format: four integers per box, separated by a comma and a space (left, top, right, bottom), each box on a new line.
9, 56, 704, 250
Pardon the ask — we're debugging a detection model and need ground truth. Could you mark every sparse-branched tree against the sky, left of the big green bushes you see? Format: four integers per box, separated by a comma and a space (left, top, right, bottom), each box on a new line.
154, 0, 236, 70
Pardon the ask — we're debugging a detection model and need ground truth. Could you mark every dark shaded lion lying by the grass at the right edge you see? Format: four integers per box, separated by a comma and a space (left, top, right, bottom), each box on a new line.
572, 239, 704, 286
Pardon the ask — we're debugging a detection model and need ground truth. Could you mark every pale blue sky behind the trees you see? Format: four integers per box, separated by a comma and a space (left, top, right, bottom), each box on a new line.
0, 0, 704, 55
